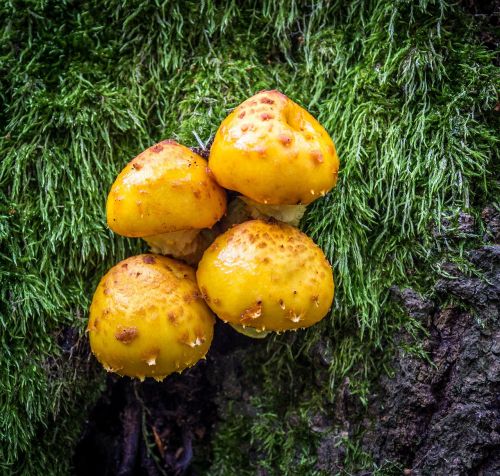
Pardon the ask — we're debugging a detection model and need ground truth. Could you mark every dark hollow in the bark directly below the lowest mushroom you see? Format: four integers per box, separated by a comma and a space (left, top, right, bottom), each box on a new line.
74, 322, 255, 476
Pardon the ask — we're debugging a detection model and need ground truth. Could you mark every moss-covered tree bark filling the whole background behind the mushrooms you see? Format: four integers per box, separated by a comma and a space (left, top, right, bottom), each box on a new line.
0, 0, 500, 475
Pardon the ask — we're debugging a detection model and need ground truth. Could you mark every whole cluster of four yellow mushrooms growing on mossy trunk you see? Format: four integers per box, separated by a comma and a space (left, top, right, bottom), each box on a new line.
87, 91, 339, 380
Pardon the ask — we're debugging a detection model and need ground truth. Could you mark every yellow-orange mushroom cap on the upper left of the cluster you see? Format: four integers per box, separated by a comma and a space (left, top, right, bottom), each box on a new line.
106, 140, 226, 237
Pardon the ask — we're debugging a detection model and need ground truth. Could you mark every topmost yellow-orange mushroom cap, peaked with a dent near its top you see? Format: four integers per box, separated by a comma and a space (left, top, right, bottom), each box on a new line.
208, 91, 339, 205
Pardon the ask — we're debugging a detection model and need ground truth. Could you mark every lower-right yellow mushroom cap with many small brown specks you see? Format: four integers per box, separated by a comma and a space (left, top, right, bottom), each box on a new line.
196, 220, 334, 331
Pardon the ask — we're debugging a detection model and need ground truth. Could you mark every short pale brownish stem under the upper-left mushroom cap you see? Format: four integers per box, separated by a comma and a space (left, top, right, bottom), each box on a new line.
144, 230, 210, 263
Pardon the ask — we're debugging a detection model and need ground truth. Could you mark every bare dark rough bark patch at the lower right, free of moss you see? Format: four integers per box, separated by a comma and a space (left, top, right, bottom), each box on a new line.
365, 245, 500, 476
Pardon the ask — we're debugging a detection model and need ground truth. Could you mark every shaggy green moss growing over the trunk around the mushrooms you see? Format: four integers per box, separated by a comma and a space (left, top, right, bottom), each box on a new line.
0, 0, 498, 474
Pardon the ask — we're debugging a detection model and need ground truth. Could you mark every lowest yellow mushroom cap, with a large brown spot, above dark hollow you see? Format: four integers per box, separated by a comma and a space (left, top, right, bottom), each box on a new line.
88, 254, 215, 380
